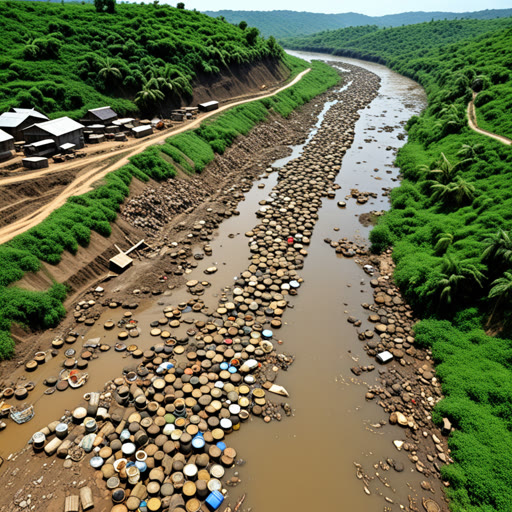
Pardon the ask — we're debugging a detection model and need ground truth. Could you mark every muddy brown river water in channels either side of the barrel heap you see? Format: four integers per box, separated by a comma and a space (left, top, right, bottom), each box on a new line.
0, 52, 425, 512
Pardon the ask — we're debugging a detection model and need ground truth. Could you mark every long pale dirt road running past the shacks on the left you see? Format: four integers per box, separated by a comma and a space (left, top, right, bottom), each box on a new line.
0, 68, 310, 244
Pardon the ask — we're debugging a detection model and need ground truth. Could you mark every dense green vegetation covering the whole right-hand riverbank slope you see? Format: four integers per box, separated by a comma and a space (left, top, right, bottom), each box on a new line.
284, 19, 512, 512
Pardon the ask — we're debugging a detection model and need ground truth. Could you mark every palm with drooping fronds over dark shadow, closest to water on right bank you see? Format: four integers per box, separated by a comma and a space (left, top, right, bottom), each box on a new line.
431, 256, 485, 308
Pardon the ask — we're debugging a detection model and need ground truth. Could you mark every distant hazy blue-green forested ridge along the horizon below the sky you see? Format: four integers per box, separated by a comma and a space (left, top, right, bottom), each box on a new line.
204, 9, 512, 38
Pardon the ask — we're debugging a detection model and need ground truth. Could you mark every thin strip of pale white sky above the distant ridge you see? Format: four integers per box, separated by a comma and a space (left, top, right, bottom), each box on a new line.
173, 0, 512, 16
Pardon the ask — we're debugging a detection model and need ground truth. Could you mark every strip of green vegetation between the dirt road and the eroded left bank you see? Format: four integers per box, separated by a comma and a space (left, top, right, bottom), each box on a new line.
0, 57, 339, 359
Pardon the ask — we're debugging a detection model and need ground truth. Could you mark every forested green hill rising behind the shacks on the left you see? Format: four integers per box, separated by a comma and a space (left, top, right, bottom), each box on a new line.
0, 1, 282, 117
